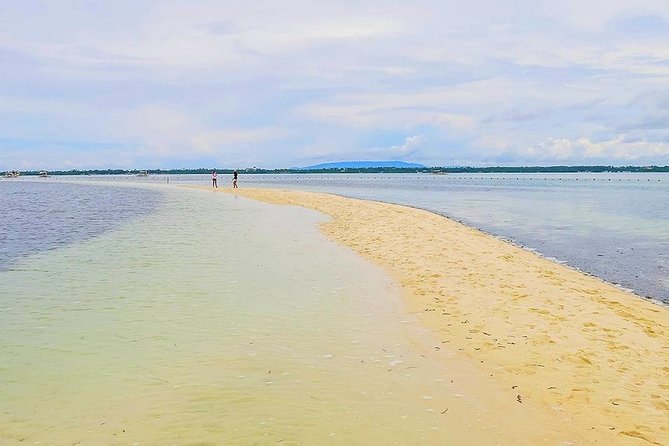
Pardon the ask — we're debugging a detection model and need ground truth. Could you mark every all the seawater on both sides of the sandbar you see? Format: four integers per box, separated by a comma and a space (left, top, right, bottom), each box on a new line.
0, 174, 669, 445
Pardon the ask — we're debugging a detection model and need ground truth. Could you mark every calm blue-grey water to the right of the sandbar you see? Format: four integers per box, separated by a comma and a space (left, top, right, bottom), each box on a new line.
150, 173, 669, 303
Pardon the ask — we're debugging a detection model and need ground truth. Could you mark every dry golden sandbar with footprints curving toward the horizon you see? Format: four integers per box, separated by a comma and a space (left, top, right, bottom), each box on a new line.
221, 189, 669, 444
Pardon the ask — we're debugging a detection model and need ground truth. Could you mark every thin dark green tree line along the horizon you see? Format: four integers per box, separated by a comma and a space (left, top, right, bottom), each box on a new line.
2, 166, 669, 175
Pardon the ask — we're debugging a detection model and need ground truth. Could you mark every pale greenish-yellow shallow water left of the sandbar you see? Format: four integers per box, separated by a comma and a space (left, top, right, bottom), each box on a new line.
0, 183, 528, 445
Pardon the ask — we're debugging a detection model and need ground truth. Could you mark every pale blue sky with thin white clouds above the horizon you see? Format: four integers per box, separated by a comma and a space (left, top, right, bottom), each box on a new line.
0, 0, 669, 170
